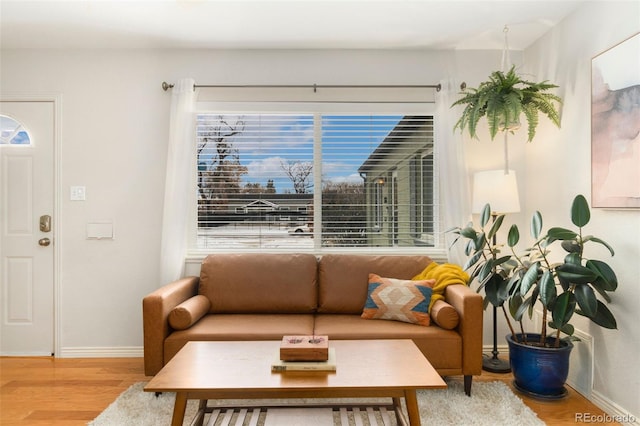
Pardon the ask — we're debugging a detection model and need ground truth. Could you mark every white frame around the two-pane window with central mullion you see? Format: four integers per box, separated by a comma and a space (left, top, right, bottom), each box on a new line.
187, 101, 447, 262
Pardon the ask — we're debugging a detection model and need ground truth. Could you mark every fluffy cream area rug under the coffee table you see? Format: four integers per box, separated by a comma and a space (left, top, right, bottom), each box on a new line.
88, 379, 544, 426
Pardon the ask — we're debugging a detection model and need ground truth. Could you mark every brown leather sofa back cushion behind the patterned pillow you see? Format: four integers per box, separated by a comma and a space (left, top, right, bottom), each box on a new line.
318, 254, 431, 314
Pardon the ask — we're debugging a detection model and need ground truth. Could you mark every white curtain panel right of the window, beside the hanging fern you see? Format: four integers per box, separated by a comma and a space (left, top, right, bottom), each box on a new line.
435, 79, 471, 265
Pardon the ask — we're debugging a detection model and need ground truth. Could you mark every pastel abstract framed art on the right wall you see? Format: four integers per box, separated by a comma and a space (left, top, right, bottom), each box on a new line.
591, 33, 640, 208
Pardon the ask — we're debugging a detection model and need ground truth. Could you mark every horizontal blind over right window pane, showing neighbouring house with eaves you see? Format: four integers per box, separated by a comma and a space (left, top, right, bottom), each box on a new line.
330, 115, 435, 247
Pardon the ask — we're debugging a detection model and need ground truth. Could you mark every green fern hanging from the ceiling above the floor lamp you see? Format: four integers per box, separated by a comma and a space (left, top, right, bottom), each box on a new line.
451, 66, 562, 142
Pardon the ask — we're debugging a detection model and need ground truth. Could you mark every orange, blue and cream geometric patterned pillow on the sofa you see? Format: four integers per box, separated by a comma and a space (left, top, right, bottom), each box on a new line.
362, 274, 436, 326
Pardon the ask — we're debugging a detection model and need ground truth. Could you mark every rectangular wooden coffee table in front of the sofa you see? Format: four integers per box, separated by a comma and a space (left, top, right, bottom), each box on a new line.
144, 340, 447, 426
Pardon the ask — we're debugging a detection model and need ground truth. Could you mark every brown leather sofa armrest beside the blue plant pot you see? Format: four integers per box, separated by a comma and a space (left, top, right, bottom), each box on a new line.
445, 284, 484, 376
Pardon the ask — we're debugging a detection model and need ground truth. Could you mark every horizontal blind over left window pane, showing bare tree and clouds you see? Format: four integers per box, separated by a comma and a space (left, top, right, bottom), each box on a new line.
196, 114, 314, 249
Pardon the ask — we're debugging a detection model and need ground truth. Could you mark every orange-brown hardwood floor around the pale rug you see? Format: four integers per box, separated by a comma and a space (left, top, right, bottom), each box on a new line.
0, 357, 619, 426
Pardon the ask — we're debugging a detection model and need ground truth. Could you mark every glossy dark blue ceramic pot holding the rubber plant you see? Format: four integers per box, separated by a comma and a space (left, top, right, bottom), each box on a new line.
507, 333, 573, 399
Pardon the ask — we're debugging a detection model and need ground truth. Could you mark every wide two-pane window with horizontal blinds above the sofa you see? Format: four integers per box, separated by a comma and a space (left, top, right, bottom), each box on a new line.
196, 113, 439, 251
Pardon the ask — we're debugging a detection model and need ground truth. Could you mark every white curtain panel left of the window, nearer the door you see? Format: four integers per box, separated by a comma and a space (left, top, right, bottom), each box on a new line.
160, 78, 196, 285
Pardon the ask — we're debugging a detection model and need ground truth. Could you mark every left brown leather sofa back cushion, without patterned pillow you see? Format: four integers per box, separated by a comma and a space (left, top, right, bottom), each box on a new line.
198, 253, 318, 314
